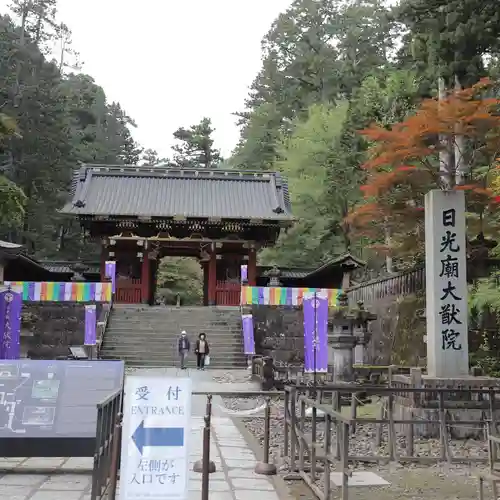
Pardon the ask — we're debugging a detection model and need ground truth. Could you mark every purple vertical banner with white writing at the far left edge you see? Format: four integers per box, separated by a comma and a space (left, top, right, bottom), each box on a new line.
0, 288, 23, 359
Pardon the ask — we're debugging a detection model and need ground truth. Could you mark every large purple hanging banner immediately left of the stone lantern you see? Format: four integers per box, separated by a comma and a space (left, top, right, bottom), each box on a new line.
302, 293, 328, 373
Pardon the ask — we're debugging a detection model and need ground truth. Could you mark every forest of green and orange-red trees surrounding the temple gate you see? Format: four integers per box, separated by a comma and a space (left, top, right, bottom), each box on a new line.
0, 0, 500, 368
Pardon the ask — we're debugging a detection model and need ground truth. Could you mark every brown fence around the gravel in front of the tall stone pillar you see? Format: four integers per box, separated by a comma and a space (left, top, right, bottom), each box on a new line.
283, 385, 500, 500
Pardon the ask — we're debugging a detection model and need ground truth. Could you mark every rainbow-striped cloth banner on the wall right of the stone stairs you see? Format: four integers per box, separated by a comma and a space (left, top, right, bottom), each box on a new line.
241, 286, 342, 307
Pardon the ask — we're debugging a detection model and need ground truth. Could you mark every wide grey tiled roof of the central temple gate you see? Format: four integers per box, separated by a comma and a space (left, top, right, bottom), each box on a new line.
62, 165, 293, 221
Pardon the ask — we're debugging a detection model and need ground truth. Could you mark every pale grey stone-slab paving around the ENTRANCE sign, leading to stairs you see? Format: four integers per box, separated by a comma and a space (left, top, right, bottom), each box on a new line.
0, 368, 280, 500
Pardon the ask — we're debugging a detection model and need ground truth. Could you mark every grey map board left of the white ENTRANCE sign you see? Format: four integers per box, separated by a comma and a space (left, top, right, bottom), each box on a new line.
0, 359, 124, 438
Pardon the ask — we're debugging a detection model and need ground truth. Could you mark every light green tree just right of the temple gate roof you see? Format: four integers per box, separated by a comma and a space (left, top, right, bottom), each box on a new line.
262, 103, 359, 266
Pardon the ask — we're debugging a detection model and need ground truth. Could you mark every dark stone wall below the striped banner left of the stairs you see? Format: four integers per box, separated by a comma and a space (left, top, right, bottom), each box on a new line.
21, 302, 102, 359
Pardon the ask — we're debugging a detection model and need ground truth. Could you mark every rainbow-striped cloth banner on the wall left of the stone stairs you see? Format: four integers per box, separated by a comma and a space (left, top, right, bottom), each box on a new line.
3, 281, 112, 302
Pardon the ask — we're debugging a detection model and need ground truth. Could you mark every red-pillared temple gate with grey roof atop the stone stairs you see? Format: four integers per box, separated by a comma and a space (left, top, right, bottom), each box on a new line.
62, 165, 294, 306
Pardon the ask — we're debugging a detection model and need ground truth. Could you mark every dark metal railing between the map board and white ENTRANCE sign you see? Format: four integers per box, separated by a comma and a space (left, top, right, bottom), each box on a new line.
90, 389, 123, 500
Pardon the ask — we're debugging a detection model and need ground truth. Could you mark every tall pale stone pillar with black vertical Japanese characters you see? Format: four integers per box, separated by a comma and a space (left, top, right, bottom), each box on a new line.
425, 190, 469, 377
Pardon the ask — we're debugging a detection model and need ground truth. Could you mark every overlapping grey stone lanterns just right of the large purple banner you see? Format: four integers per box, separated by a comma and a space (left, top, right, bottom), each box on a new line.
328, 292, 376, 383
